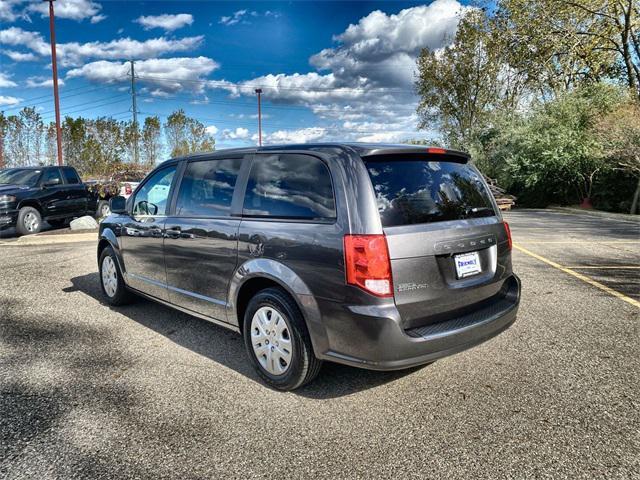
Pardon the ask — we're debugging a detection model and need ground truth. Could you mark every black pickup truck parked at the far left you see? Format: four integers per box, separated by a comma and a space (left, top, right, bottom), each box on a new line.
0, 167, 97, 235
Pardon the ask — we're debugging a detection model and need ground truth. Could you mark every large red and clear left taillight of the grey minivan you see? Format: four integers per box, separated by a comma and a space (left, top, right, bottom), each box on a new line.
344, 235, 393, 297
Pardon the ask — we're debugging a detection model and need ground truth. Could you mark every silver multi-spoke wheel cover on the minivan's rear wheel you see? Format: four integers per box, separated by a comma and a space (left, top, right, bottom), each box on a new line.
251, 307, 293, 376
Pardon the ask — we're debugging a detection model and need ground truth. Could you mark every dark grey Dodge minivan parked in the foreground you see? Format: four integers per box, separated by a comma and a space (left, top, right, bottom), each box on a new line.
98, 144, 520, 390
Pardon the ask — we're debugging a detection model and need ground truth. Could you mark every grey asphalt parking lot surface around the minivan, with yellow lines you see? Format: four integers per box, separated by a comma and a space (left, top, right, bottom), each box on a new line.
0, 210, 640, 479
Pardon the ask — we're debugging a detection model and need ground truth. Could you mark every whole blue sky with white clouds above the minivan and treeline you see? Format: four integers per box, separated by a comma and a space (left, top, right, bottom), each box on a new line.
0, 0, 466, 147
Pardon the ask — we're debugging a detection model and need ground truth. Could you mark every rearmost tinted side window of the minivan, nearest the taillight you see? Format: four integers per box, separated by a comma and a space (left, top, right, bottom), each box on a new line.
243, 154, 336, 220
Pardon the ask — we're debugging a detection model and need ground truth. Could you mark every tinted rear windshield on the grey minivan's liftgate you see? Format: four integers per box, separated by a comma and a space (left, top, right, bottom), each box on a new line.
365, 160, 495, 227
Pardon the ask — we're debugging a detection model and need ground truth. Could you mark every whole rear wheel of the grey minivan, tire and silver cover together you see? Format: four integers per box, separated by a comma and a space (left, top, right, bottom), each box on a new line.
243, 288, 322, 390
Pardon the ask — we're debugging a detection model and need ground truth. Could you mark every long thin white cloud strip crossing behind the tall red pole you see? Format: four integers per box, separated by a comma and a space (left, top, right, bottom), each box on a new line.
0, 27, 204, 67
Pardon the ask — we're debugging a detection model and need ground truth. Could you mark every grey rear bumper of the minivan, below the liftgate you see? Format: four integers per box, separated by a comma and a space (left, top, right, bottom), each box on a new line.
319, 275, 520, 370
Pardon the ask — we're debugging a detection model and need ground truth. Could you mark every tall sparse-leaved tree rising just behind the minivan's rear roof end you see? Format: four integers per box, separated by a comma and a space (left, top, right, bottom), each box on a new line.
416, 10, 524, 150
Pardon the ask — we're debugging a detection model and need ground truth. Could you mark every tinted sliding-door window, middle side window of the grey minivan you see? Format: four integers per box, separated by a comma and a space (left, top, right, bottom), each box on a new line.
176, 158, 242, 217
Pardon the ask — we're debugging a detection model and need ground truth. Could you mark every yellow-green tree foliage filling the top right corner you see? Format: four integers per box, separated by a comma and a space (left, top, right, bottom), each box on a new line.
496, 0, 640, 97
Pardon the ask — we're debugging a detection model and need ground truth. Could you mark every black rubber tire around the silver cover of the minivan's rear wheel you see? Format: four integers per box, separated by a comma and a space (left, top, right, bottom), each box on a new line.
243, 288, 322, 390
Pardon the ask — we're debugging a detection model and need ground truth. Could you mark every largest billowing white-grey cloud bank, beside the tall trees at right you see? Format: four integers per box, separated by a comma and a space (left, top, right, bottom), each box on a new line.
208, 0, 470, 141
